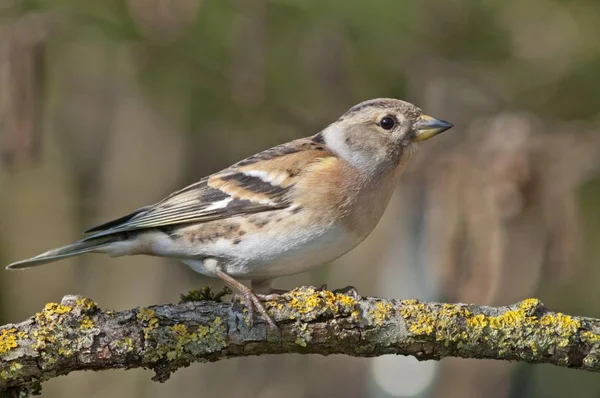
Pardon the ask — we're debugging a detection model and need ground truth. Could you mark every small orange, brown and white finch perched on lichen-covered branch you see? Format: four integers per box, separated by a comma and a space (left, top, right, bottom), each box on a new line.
7, 98, 453, 328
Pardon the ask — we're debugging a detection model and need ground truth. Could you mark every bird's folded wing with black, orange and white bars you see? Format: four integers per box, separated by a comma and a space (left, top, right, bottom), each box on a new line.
85, 134, 331, 239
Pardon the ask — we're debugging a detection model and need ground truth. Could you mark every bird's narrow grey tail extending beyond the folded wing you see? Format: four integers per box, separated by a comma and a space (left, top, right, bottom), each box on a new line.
6, 236, 118, 269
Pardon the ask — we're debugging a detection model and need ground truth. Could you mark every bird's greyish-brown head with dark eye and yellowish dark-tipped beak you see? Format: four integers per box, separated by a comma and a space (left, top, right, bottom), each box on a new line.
322, 98, 452, 173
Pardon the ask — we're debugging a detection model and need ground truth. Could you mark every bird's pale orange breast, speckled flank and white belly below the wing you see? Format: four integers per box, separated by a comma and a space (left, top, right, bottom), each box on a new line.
168, 160, 395, 279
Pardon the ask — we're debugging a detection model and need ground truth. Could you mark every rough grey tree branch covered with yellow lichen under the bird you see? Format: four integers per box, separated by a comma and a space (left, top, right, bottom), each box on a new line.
0, 287, 600, 396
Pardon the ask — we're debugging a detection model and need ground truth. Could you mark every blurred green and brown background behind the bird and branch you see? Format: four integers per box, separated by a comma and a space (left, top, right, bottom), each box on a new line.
0, 0, 600, 398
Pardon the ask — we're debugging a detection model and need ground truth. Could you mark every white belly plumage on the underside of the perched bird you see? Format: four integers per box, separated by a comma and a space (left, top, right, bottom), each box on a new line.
181, 226, 362, 279
